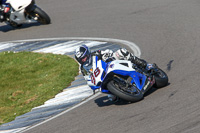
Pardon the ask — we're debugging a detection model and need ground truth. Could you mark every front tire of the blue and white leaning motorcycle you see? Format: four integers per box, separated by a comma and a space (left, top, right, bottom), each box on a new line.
107, 80, 143, 102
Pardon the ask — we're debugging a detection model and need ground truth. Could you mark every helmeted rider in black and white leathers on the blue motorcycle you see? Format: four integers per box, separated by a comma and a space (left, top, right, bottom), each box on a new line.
75, 45, 152, 101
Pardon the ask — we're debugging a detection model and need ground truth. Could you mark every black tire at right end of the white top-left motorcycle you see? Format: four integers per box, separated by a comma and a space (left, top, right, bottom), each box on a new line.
33, 7, 51, 24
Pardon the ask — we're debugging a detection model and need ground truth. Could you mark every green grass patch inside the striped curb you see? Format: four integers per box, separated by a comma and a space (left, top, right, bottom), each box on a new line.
0, 52, 78, 124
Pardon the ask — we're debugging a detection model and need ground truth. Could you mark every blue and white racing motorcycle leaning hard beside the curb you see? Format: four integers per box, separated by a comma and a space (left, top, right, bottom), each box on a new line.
87, 56, 168, 102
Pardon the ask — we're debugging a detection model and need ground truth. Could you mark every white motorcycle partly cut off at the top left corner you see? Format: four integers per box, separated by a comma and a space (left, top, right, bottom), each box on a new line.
0, 0, 51, 28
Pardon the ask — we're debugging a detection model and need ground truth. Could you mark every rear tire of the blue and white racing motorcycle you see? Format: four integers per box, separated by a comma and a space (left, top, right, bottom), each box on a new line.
154, 68, 168, 88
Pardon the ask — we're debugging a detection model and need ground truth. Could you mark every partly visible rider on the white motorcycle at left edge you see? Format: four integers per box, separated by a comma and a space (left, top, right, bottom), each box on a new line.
0, 0, 10, 22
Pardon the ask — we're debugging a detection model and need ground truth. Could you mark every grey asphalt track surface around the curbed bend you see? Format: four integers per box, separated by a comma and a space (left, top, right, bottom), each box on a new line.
0, 0, 200, 133
